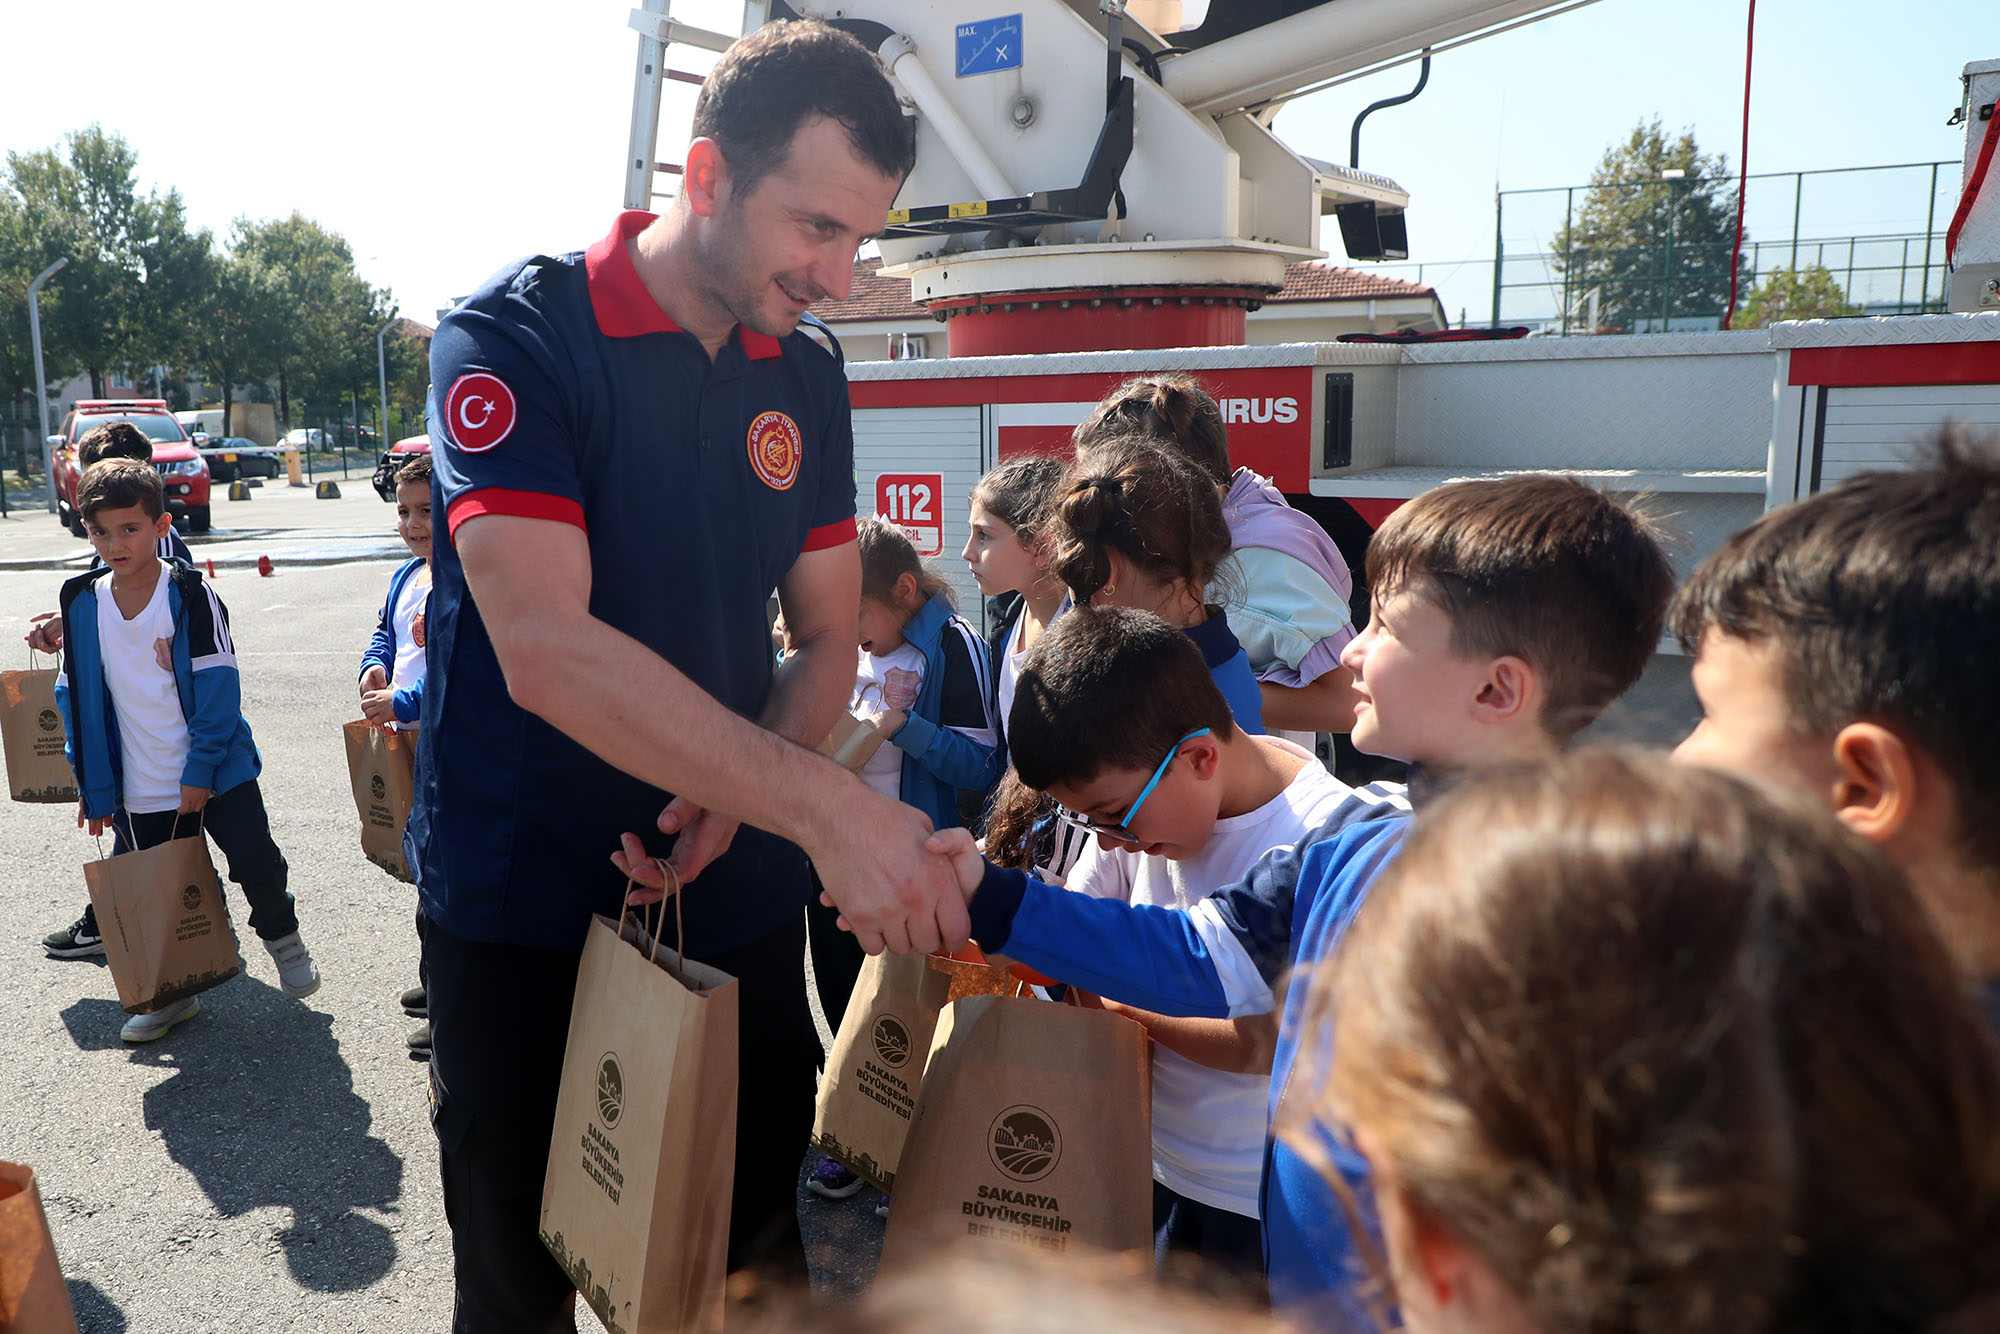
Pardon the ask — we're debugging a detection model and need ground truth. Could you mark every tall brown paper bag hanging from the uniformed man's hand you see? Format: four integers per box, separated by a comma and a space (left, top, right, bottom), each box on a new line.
542, 896, 736, 1334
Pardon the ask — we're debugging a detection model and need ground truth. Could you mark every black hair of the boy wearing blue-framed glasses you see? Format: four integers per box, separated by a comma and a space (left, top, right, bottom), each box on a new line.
1006, 606, 1234, 792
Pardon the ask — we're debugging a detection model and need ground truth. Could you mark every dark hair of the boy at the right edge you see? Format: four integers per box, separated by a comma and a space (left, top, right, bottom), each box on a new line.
1672, 428, 2000, 868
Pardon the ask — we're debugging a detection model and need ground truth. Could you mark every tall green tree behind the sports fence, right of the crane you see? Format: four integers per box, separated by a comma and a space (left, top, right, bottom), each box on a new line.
1554, 118, 1736, 330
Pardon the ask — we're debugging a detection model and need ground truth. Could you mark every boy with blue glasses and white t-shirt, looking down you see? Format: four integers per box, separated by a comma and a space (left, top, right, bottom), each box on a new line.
1006, 606, 1350, 1282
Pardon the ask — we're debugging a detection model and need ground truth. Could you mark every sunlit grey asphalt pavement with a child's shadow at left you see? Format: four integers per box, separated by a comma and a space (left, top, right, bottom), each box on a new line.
0, 482, 882, 1334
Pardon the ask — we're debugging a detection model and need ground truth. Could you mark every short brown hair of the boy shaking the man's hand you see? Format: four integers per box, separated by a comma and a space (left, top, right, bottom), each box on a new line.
1368, 476, 1674, 742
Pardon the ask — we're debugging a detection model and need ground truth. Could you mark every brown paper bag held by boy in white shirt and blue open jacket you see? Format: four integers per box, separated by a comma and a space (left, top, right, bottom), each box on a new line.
84, 818, 242, 1014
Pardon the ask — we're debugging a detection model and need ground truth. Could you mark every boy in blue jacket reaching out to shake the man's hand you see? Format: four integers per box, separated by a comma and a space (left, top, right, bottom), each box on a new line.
932, 478, 1674, 1320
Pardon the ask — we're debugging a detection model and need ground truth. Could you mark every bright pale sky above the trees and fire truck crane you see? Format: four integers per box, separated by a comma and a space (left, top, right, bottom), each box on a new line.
0, 0, 2000, 322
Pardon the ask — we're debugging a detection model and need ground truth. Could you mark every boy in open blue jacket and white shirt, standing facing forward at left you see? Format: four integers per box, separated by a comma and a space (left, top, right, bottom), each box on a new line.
56, 460, 320, 1042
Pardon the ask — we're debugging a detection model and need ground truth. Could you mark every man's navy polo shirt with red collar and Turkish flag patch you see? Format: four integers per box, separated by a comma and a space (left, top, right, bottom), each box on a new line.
406, 212, 854, 958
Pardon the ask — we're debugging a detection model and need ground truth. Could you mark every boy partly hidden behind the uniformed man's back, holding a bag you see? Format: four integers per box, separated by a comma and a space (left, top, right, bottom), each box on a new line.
360, 454, 430, 1056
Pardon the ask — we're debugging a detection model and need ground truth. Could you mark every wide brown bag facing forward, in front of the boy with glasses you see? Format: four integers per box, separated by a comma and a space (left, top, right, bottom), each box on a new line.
882, 996, 1152, 1266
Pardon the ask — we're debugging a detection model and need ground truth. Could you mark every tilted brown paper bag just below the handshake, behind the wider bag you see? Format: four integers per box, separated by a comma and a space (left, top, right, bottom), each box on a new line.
812, 954, 952, 1190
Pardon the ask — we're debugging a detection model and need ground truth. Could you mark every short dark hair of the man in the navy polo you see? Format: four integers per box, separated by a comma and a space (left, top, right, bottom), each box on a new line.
694, 20, 916, 200
